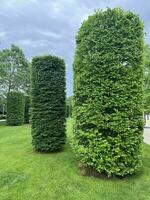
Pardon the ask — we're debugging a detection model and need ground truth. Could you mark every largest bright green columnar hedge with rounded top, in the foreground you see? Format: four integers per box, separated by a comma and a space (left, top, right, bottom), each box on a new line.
74, 8, 143, 176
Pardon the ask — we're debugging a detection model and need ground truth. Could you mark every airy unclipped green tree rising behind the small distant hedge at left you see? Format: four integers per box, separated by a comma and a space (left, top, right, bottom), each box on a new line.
0, 45, 30, 96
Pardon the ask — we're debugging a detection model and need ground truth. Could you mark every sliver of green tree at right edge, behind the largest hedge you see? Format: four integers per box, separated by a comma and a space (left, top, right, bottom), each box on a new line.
144, 44, 150, 113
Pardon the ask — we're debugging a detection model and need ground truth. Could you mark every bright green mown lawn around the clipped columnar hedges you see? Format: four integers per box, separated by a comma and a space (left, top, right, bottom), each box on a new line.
0, 120, 150, 200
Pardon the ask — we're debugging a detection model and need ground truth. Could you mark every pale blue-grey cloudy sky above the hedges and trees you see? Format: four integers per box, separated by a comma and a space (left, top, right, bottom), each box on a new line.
0, 0, 150, 95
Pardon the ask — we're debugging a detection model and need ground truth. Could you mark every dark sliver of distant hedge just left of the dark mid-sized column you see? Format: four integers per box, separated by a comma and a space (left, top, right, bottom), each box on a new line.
24, 96, 30, 124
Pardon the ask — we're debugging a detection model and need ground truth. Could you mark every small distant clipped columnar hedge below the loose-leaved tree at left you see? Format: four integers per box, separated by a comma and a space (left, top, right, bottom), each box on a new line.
7, 91, 25, 126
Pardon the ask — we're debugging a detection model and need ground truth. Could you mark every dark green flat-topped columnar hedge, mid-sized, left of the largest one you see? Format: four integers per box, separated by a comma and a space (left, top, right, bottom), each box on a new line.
31, 56, 66, 152
